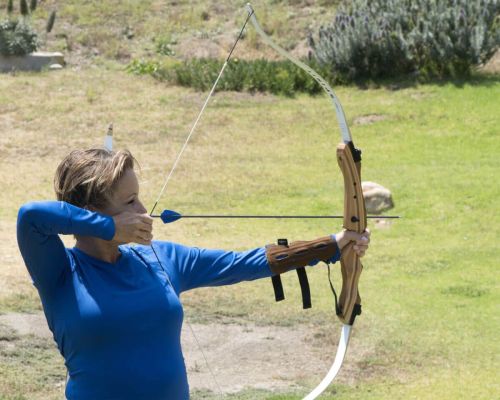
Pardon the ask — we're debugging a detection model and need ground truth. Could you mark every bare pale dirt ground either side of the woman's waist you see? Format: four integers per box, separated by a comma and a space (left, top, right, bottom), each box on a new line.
0, 313, 363, 393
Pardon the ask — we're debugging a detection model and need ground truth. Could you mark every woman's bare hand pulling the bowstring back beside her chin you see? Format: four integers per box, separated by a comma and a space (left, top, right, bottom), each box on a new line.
112, 211, 153, 245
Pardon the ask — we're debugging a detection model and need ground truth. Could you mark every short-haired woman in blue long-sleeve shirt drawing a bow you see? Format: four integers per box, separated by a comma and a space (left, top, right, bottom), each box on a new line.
17, 149, 369, 400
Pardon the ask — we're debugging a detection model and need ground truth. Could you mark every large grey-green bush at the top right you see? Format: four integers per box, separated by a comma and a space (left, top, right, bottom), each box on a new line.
310, 0, 500, 80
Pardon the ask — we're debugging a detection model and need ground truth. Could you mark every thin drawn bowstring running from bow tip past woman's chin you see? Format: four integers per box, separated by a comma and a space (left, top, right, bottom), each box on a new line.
149, 12, 253, 397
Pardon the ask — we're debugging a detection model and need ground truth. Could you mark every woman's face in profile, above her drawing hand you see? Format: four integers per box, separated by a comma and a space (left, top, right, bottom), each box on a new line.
100, 168, 147, 216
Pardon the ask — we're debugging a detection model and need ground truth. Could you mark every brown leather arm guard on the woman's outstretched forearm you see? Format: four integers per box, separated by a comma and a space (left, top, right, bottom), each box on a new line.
266, 236, 338, 274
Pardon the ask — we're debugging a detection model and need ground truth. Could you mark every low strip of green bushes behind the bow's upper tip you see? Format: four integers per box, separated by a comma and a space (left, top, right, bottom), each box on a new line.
127, 58, 336, 96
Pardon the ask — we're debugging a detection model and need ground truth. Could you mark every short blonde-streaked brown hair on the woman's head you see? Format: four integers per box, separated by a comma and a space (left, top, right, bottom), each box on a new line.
54, 149, 137, 208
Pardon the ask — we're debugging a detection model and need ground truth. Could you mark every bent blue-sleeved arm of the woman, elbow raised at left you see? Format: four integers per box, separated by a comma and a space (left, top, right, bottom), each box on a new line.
17, 201, 115, 295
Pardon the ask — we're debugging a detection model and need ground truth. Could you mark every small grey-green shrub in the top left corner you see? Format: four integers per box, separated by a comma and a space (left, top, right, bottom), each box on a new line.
0, 0, 56, 56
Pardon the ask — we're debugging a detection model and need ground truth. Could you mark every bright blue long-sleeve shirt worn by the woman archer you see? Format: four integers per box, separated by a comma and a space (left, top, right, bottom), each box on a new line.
17, 201, 340, 400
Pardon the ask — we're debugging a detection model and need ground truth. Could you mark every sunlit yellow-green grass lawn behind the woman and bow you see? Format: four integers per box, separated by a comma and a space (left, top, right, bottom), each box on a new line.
0, 65, 500, 399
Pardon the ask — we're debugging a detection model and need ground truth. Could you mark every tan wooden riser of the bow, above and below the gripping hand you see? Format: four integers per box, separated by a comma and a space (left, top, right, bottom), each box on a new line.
337, 143, 366, 325
